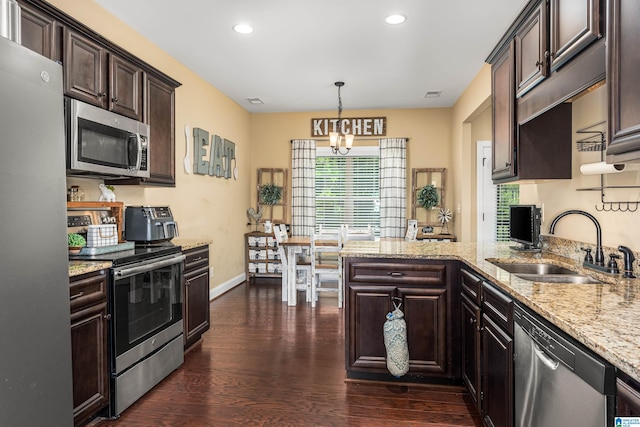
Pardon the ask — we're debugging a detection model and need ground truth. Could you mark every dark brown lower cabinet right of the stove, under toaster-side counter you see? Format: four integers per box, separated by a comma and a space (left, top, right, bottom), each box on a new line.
183, 246, 210, 348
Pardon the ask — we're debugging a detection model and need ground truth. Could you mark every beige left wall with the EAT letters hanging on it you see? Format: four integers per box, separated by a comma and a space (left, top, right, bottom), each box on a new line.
55, 0, 254, 287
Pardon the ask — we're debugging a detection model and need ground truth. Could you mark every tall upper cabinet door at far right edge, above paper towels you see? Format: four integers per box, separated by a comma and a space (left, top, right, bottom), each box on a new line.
607, 0, 640, 162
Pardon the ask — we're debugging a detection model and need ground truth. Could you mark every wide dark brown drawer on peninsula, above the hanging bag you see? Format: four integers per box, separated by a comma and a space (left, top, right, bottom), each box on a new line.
346, 260, 447, 286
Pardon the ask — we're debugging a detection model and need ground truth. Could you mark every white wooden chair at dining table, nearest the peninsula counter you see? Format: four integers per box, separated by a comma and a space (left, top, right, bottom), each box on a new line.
310, 230, 343, 308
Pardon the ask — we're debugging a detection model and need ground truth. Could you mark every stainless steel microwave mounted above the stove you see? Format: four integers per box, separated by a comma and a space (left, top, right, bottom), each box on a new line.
64, 97, 149, 178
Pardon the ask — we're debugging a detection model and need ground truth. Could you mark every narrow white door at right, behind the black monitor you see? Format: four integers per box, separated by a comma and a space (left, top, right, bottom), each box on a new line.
476, 141, 496, 243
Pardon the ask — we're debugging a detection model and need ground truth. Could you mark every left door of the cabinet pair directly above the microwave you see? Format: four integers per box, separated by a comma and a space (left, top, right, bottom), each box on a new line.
64, 28, 108, 108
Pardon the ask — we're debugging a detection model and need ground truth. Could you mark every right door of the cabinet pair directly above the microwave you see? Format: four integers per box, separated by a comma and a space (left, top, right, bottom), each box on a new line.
109, 54, 143, 120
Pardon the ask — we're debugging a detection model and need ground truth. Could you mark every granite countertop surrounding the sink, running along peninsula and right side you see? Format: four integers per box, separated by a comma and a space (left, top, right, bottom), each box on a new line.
340, 239, 640, 381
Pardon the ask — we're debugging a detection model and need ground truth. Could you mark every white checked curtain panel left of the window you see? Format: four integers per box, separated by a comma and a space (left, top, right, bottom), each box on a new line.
291, 139, 316, 236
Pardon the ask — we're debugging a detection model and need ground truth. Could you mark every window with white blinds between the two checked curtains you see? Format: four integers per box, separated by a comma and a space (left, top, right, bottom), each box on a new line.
316, 147, 380, 235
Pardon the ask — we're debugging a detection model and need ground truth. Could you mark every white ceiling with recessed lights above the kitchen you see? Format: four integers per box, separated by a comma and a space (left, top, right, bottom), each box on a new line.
95, 0, 527, 113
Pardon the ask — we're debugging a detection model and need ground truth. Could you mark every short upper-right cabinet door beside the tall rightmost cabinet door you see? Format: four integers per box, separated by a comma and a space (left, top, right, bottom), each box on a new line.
550, 0, 600, 71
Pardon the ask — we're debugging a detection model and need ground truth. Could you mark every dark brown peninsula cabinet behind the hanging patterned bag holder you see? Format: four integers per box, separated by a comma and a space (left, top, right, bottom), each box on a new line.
345, 258, 460, 380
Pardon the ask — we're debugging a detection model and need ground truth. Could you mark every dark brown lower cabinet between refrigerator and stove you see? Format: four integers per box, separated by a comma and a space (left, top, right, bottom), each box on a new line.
69, 270, 109, 426
